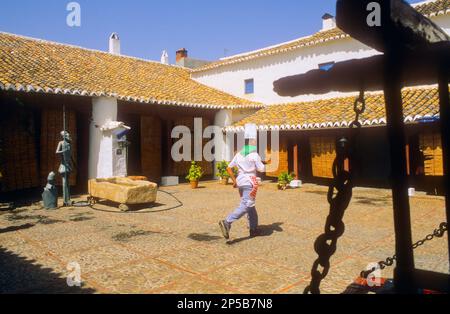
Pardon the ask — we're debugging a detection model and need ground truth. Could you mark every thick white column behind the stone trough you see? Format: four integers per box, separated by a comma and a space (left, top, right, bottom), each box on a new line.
89, 97, 117, 179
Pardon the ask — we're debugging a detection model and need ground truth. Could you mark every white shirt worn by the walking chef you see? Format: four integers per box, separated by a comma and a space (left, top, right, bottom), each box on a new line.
229, 152, 266, 187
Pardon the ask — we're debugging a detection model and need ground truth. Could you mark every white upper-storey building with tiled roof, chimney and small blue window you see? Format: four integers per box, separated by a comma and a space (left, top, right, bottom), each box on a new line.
192, 0, 450, 105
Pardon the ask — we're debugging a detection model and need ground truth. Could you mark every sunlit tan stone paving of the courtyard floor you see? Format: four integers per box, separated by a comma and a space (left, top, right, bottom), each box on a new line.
0, 182, 449, 294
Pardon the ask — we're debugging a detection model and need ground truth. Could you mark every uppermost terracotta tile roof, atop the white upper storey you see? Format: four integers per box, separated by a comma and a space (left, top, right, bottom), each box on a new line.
192, 0, 450, 73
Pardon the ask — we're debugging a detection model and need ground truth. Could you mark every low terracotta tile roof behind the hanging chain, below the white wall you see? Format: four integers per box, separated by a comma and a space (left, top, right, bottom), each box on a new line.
226, 87, 439, 132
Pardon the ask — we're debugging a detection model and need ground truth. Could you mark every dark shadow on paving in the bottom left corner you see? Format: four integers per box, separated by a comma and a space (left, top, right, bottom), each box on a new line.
0, 247, 95, 294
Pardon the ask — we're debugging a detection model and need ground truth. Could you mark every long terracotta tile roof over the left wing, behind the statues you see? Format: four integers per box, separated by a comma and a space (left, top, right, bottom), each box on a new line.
0, 32, 263, 109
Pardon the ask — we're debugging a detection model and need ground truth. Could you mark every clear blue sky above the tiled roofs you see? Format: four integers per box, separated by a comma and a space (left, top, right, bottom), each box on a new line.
0, 0, 419, 62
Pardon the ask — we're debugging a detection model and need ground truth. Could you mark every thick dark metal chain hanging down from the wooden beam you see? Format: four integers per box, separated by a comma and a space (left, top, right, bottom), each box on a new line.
304, 89, 366, 294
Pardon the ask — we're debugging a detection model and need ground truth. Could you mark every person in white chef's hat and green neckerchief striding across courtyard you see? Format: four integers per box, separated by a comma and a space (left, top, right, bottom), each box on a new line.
219, 124, 265, 240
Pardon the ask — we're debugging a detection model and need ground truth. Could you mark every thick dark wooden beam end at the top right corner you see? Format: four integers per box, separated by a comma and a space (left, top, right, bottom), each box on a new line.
336, 0, 450, 52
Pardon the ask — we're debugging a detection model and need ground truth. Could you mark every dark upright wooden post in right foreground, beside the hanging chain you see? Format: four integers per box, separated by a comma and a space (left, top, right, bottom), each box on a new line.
384, 49, 415, 293
